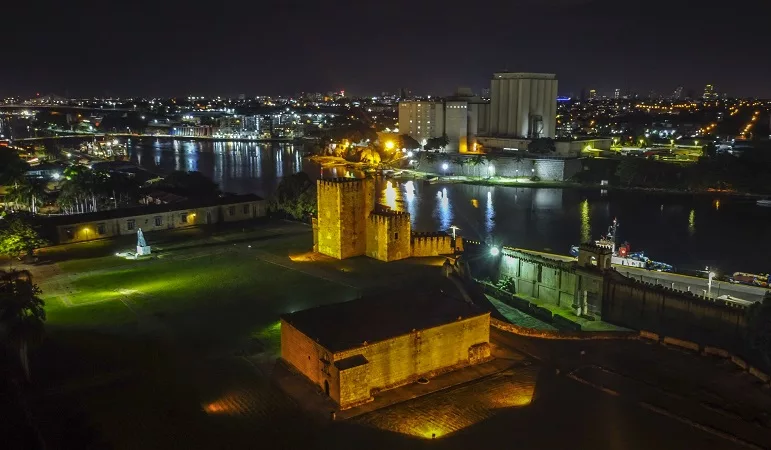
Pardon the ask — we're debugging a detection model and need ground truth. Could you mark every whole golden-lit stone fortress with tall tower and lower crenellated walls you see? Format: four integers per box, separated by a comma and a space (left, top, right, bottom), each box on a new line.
313, 178, 463, 261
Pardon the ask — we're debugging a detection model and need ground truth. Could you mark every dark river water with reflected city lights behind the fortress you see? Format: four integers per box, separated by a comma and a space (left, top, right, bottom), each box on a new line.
128, 139, 771, 274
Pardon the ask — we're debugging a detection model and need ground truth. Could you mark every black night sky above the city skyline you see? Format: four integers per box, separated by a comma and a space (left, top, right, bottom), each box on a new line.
6, 0, 771, 98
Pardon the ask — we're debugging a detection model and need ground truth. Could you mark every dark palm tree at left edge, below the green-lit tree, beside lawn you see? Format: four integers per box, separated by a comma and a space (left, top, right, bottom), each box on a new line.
0, 271, 46, 381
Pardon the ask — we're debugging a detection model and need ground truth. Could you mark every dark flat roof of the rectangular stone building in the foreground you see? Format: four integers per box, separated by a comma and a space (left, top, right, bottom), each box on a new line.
281, 286, 489, 352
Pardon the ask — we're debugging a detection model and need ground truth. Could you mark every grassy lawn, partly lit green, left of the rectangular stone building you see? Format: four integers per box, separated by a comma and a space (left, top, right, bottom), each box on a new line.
22, 223, 372, 448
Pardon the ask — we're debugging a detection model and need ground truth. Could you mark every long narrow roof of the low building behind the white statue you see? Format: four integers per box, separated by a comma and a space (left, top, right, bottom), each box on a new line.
42, 194, 262, 226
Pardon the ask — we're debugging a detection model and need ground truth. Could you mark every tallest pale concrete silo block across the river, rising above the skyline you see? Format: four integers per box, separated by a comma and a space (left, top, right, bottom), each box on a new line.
488, 72, 557, 138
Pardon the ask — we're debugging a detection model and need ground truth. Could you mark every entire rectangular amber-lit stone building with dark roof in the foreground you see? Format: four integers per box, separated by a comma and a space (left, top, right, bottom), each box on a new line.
281, 289, 490, 409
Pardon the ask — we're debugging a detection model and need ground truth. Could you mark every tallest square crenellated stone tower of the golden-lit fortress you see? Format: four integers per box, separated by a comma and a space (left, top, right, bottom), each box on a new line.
314, 178, 375, 259
